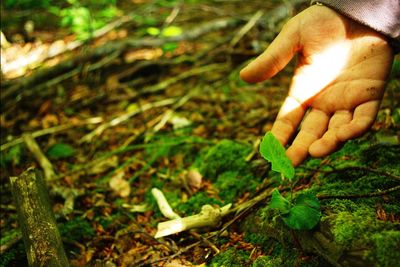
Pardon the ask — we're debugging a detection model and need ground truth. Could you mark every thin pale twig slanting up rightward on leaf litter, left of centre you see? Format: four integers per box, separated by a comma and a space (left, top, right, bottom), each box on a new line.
79, 98, 176, 143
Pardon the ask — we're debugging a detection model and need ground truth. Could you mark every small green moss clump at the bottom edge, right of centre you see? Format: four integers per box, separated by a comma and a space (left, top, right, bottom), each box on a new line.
207, 248, 250, 267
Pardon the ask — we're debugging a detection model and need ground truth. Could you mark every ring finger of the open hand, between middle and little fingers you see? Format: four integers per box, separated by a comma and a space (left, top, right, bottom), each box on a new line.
308, 110, 353, 157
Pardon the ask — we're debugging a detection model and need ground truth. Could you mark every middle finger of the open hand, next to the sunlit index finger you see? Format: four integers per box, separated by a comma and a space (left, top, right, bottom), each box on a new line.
286, 109, 330, 166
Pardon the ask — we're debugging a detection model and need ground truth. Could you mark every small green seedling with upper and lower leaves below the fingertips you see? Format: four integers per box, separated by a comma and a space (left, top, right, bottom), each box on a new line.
260, 132, 321, 230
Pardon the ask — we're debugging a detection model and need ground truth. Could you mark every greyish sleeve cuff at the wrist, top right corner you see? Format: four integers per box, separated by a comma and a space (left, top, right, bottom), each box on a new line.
311, 0, 400, 52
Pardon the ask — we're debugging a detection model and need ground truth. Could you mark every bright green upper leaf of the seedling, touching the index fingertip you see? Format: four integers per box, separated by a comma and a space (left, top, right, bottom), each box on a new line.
260, 132, 294, 180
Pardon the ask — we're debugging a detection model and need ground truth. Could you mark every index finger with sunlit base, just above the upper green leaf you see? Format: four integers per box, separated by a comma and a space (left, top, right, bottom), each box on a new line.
271, 96, 306, 146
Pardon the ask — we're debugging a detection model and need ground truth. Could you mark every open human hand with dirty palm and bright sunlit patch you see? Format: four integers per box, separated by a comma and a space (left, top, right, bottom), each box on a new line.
240, 6, 393, 166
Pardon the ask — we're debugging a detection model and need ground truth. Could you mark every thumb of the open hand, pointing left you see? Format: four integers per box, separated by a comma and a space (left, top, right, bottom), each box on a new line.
240, 22, 300, 83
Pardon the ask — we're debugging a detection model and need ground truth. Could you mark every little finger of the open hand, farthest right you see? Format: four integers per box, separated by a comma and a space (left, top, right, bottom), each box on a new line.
337, 100, 380, 142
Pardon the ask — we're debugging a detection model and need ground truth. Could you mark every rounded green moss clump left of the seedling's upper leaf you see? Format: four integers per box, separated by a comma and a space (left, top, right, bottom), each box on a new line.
195, 140, 252, 181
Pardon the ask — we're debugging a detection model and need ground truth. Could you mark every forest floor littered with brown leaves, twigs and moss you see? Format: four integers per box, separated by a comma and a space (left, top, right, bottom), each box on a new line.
0, 0, 400, 266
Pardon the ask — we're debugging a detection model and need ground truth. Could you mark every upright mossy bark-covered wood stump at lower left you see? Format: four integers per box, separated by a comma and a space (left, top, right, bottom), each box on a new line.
10, 168, 69, 267
